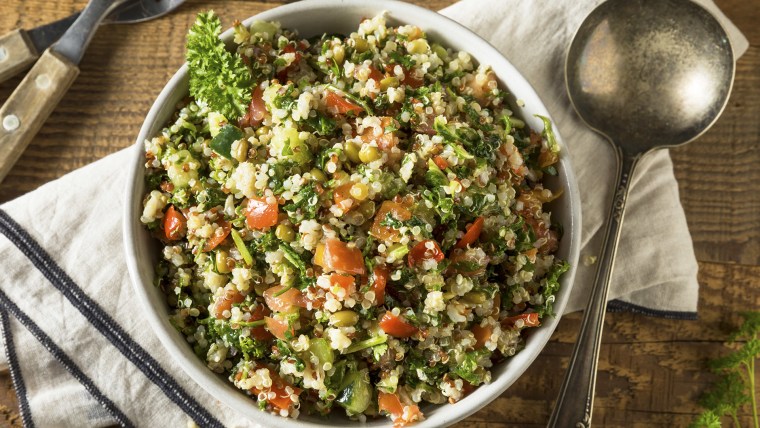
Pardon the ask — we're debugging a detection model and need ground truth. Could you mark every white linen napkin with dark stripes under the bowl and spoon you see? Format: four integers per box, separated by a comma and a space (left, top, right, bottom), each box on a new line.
0, 0, 747, 427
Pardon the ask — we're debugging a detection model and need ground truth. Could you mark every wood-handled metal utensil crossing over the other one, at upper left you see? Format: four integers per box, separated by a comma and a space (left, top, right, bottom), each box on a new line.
0, 0, 181, 181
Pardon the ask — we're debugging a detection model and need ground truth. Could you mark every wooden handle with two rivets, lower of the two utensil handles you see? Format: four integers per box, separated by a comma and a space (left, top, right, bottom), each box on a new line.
0, 48, 79, 181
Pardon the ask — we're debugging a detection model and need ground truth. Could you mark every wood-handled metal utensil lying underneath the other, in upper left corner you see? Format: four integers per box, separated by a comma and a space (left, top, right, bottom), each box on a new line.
0, 0, 184, 82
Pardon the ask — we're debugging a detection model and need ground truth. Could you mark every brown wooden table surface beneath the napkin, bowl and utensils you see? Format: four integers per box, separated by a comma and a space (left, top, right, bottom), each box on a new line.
0, 0, 760, 428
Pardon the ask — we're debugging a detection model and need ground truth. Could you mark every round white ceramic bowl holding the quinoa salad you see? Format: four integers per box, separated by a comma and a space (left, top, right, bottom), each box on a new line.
124, 0, 581, 428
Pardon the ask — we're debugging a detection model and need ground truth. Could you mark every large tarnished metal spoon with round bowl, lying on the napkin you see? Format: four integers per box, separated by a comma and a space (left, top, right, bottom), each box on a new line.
549, 0, 734, 427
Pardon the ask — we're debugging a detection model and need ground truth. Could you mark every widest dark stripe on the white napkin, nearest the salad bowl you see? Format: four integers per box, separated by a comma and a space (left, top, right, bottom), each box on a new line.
0, 210, 224, 428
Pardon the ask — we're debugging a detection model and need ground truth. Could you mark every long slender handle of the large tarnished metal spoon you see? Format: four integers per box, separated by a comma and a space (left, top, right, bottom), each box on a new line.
548, 147, 639, 428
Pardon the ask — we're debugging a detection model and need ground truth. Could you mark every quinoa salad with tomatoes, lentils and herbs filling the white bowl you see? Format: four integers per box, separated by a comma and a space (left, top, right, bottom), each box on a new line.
140, 12, 569, 426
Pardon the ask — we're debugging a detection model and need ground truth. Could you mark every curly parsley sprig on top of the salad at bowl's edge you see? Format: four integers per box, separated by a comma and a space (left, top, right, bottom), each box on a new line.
186, 11, 251, 119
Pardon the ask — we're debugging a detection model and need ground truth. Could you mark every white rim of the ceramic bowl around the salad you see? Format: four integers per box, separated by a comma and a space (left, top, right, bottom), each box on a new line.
123, 0, 582, 428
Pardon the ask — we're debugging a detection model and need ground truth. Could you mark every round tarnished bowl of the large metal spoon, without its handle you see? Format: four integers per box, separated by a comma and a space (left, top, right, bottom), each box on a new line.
565, 0, 734, 152
